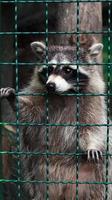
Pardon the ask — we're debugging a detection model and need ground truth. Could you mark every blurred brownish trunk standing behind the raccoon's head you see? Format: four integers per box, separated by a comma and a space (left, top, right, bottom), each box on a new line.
55, 2, 102, 73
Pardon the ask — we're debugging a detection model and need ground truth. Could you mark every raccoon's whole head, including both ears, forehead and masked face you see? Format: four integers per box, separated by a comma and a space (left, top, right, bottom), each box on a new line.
31, 42, 103, 93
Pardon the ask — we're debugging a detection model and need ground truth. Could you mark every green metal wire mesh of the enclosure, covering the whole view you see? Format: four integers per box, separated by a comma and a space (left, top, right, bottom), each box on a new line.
0, 0, 112, 200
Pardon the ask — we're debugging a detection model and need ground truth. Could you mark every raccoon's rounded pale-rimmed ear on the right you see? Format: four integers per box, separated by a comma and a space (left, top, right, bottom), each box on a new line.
89, 43, 103, 57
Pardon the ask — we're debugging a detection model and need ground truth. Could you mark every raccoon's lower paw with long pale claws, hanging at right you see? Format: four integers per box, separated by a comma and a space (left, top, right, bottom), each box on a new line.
87, 149, 103, 161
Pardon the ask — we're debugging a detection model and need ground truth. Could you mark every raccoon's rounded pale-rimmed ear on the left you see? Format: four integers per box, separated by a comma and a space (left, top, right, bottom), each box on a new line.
30, 41, 46, 60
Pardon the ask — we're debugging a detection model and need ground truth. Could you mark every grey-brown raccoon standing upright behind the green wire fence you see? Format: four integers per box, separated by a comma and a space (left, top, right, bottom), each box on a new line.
0, 38, 111, 200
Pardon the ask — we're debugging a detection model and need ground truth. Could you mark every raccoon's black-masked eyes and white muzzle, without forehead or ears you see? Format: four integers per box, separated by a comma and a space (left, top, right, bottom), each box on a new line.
46, 64, 88, 93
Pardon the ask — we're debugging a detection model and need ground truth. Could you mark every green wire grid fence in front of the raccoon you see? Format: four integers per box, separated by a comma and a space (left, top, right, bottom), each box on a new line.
0, 0, 112, 200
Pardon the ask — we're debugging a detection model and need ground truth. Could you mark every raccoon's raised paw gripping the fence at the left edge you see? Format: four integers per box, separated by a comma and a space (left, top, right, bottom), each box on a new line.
0, 87, 15, 98
